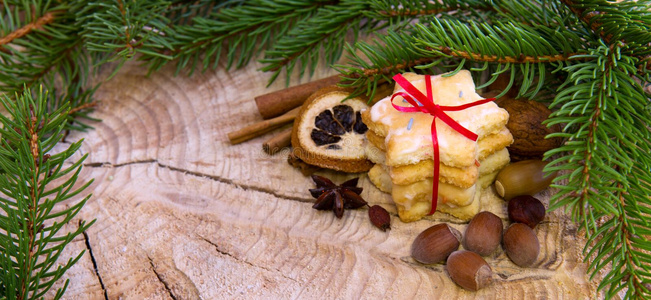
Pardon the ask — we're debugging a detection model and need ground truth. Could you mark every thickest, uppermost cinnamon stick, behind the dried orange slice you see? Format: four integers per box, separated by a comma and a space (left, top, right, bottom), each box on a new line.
255, 75, 340, 119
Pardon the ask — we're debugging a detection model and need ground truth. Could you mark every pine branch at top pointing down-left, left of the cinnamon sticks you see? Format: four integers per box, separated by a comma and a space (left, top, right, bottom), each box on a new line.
153, 0, 336, 73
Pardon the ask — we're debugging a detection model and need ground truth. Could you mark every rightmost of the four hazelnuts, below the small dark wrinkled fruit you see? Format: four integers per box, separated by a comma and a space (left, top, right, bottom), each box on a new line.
502, 223, 540, 267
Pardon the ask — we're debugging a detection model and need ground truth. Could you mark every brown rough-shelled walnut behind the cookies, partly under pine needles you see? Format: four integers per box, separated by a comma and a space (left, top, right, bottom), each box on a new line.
496, 97, 563, 161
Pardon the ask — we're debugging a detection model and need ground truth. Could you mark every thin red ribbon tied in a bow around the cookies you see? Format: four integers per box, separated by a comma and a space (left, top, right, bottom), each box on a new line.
391, 74, 495, 215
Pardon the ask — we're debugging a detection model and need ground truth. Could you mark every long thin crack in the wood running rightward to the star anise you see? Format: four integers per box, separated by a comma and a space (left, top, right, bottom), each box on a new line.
84, 159, 314, 203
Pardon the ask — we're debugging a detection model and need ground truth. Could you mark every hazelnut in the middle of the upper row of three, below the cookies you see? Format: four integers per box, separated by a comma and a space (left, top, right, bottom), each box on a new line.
463, 211, 502, 256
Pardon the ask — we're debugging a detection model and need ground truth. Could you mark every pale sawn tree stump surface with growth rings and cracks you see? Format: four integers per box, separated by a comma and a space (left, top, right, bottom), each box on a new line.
49, 59, 595, 299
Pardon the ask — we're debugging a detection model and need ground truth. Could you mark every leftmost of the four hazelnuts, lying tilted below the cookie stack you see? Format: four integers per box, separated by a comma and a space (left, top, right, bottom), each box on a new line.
411, 223, 461, 264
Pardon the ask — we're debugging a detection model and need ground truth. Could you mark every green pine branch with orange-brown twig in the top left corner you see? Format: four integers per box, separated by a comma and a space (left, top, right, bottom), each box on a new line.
0, 1, 96, 129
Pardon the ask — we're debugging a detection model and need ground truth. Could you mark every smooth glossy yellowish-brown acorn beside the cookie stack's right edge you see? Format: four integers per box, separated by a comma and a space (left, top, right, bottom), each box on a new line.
495, 160, 558, 200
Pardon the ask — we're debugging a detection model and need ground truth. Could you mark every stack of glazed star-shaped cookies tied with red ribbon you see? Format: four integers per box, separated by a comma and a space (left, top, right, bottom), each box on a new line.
362, 70, 513, 222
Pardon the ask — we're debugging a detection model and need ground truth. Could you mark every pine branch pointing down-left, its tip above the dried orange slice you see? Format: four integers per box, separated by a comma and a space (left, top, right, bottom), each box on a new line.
261, 0, 489, 83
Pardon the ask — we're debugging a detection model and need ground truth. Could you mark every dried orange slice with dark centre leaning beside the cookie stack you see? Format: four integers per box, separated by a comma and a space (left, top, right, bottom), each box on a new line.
292, 87, 373, 173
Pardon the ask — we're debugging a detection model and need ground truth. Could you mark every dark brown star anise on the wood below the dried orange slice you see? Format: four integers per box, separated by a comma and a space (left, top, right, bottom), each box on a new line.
310, 175, 366, 218
